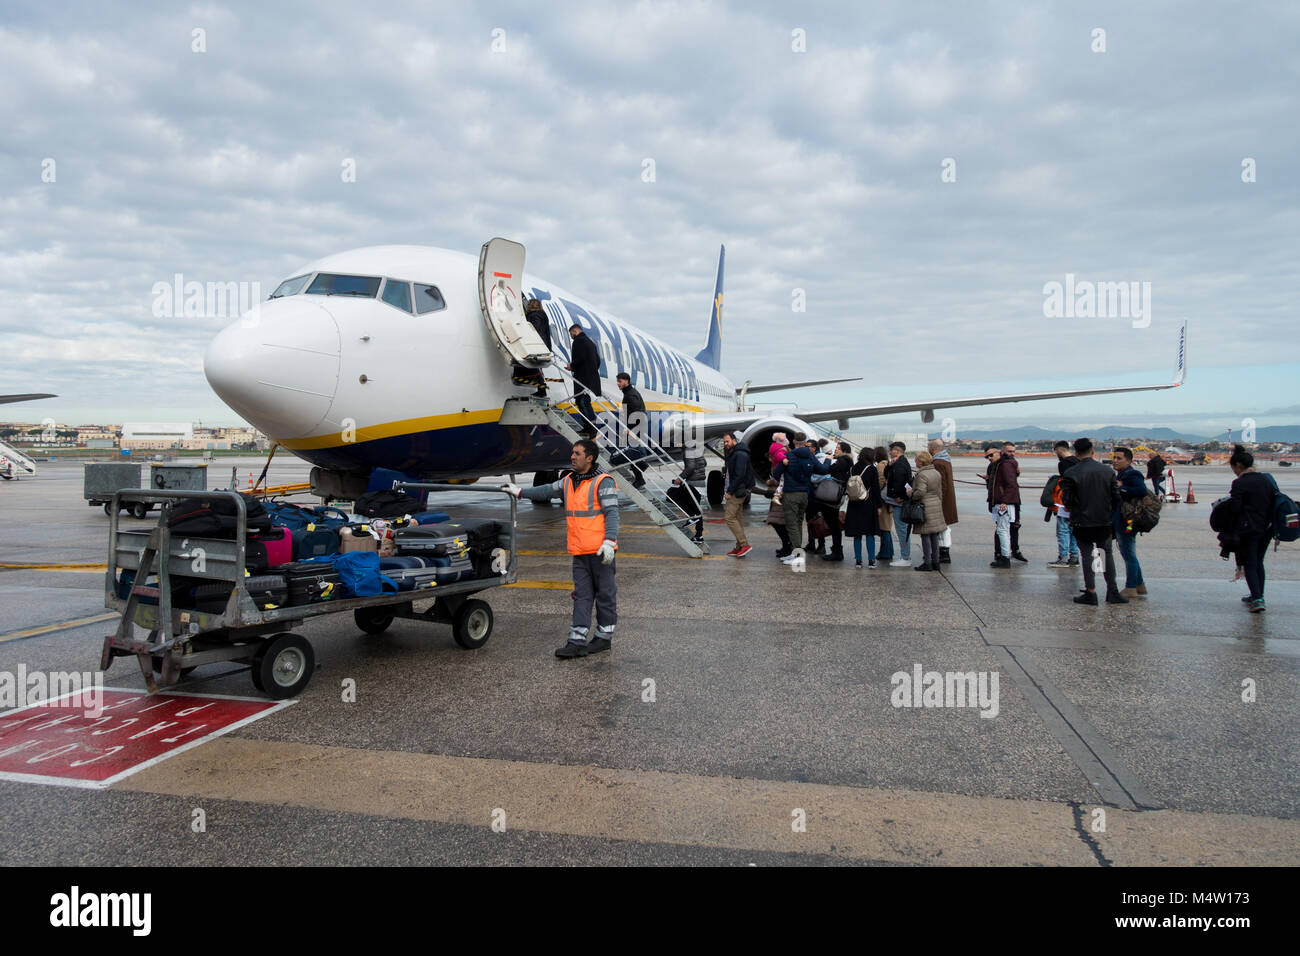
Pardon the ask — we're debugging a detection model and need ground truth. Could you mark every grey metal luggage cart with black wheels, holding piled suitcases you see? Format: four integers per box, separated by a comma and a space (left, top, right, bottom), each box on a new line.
100, 484, 517, 700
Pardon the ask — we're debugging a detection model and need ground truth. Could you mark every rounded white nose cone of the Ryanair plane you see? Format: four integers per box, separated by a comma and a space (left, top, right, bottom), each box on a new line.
203, 297, 339, 438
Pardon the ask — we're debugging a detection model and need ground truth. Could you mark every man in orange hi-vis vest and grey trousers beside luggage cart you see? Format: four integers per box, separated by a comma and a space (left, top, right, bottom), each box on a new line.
504, 438, 619, 661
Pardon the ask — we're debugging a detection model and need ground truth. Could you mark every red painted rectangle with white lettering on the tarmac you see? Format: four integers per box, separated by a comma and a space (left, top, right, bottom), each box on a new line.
0, 688, 291, 788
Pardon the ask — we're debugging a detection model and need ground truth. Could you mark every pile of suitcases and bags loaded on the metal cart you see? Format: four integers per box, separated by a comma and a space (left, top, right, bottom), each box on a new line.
158, 492, 508, 613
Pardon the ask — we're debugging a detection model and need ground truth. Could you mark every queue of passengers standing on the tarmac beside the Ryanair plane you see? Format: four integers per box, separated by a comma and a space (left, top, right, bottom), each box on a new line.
712, 432, 1277, 613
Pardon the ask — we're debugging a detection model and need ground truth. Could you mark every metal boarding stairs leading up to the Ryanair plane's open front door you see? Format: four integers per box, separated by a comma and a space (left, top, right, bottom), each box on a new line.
501, 395, 707, 558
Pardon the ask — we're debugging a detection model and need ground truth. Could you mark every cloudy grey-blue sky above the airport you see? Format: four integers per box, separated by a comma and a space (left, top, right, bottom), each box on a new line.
0, 1, 1300, 432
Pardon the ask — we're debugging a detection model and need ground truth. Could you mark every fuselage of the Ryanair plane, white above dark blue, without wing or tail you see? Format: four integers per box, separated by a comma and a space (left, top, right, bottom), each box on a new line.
204, 246, 736, 479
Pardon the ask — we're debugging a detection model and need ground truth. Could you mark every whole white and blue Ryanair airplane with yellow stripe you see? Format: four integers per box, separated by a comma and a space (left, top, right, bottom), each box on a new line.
203, 239, 1187, 501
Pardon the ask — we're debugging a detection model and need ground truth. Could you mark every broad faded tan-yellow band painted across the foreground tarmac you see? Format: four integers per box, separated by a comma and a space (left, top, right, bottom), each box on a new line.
113, 738, 1300, 866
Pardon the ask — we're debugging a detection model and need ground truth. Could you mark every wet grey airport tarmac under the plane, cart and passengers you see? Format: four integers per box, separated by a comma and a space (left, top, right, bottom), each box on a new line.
0, 458, 1300, 866
